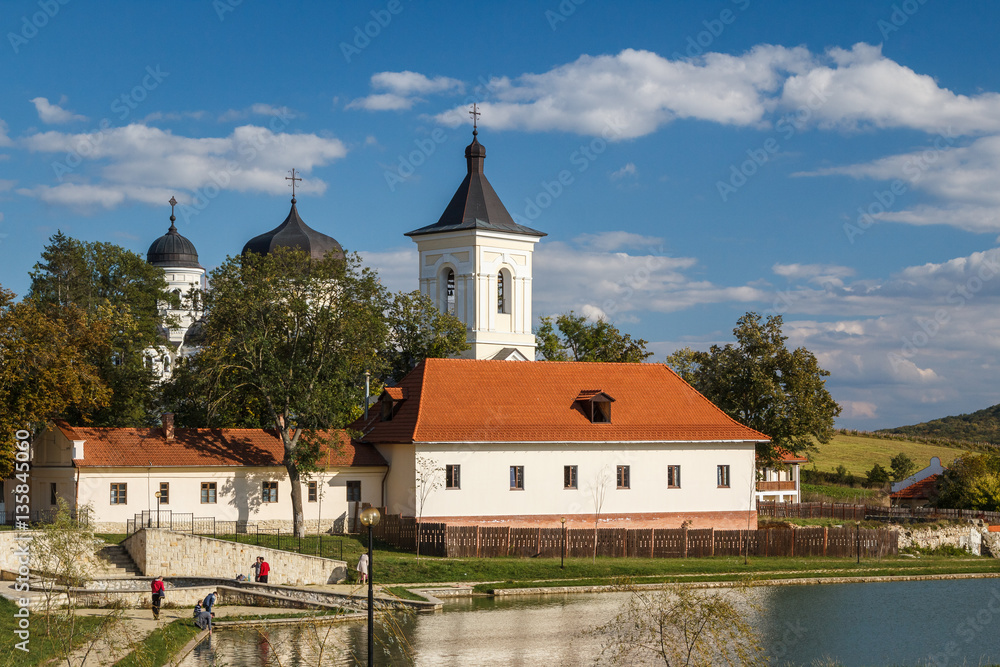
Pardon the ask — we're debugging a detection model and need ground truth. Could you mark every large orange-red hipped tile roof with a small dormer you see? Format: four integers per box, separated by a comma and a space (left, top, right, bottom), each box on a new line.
354, 359, 768, 443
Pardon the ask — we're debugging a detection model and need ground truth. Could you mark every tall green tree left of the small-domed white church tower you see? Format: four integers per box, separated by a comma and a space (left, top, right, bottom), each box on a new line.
29, 232, 177, 426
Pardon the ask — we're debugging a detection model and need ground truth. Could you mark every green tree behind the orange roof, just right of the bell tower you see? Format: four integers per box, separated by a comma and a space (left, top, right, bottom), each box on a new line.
535, 310, 653, 363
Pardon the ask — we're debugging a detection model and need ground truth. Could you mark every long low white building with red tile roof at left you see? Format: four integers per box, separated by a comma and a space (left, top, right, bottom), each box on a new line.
31, 415, 388, 532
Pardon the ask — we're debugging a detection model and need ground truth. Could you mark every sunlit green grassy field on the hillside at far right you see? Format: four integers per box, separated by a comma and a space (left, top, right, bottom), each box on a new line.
805, 433, 966, 476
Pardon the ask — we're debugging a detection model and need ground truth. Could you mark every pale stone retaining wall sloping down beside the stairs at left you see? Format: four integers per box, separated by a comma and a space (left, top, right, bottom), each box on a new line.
122, 528, 347, 586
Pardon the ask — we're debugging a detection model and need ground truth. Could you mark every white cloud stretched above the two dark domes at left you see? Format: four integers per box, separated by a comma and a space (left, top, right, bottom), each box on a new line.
19, 124, 347, 208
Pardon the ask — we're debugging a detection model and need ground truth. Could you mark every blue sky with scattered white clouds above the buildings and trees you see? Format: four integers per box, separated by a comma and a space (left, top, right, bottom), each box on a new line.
0, 0, 1000, 429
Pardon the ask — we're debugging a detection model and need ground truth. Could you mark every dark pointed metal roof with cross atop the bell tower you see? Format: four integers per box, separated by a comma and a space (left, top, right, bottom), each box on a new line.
406, 122, 546, 236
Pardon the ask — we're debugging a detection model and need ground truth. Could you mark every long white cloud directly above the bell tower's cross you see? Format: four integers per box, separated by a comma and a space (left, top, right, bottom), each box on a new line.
436, 44, 812, 139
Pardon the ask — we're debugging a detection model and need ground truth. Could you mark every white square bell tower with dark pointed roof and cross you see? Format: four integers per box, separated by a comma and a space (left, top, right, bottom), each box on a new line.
406, 118, 545, 361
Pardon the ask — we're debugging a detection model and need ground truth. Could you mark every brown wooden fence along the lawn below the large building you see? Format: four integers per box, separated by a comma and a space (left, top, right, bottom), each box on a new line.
373, 515, 898, 558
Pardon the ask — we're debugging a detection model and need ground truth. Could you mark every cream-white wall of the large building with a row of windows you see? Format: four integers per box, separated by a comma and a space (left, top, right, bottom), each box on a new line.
379, 442, 754, 521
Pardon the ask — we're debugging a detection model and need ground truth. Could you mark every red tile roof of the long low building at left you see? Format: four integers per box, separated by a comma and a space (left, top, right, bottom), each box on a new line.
56, 422, 386, 468
